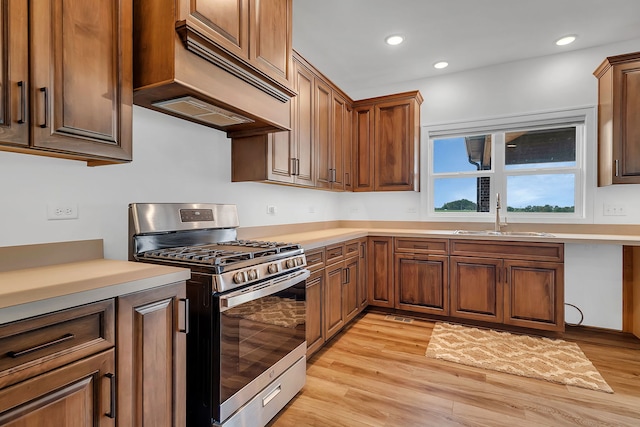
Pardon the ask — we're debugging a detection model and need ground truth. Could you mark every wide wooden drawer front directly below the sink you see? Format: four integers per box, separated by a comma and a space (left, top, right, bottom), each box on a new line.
451, 240, 564, 262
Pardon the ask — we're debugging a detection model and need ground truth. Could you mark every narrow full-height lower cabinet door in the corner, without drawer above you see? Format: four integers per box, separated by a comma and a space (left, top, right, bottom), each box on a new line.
367, 237, 394, 308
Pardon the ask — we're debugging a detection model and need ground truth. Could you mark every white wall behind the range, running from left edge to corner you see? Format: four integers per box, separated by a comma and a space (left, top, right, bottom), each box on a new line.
0, 107, 339, 259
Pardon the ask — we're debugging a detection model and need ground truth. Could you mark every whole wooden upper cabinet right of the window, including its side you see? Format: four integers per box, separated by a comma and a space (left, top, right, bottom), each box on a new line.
594, 52, 640, 186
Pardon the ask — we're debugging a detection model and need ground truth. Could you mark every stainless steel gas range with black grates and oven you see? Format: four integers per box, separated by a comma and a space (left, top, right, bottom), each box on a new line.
129, 203, 309, 427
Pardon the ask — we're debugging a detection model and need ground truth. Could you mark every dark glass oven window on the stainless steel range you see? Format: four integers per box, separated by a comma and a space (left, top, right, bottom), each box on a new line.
220, 281, 305, 402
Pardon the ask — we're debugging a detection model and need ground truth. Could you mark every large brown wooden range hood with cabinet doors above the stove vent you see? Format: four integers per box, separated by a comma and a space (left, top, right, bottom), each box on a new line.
133, 0, 295, 137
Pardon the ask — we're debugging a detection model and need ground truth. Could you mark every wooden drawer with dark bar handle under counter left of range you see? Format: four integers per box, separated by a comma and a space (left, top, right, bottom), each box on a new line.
0, 299, 115, 388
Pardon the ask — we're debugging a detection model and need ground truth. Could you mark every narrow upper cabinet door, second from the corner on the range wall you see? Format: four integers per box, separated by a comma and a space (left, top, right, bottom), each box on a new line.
314, 79, 333, 188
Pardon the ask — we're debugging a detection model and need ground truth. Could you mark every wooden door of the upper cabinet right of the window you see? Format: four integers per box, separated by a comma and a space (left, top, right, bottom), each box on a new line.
608, 60, 640, 184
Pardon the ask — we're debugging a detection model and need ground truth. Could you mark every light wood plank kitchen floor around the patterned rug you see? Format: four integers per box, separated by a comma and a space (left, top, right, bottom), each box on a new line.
269, 312, 640, 427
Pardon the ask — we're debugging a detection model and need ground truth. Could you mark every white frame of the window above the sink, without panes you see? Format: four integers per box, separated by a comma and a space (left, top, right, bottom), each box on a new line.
423, 107, 595, 223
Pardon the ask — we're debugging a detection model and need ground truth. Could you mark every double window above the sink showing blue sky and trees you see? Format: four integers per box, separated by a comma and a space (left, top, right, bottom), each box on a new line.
428, 111, 585, 220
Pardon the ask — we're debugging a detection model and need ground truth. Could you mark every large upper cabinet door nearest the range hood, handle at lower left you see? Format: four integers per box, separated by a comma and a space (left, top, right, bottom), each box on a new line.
30, 0, 133, 161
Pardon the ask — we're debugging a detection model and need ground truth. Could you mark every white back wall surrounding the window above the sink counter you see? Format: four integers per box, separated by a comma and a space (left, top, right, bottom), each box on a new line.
340, 39, 640, 224
